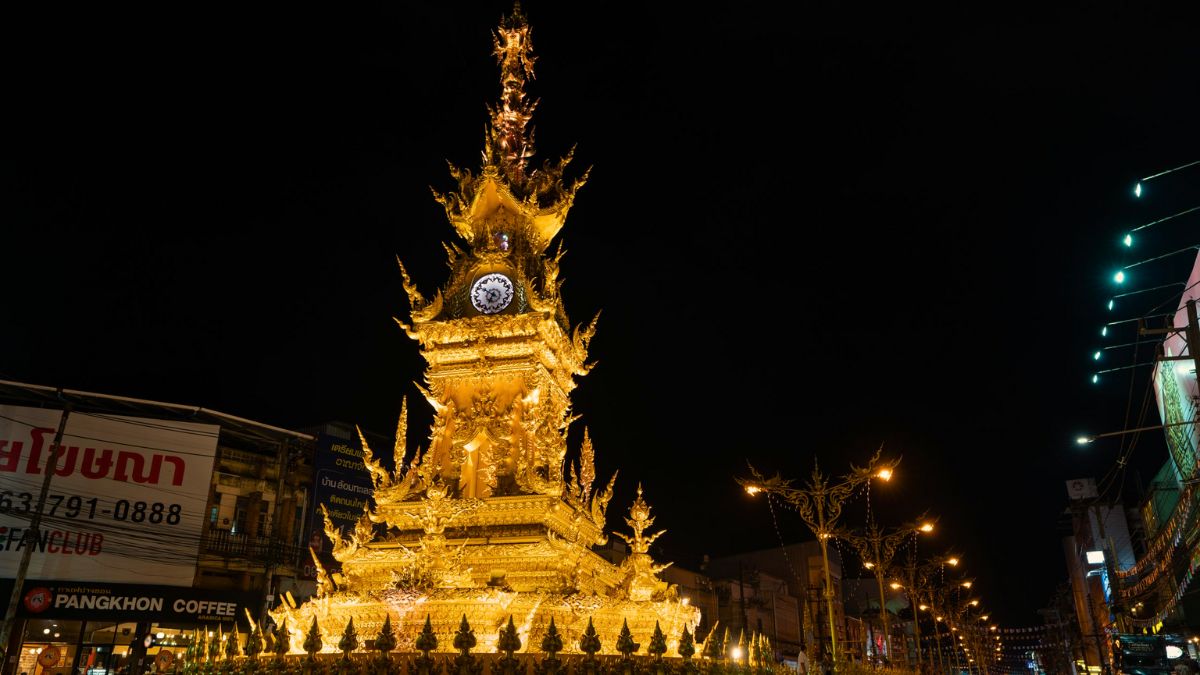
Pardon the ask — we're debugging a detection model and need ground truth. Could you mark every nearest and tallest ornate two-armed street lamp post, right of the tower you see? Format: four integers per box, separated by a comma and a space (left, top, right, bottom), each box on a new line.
736, 447, 899, 668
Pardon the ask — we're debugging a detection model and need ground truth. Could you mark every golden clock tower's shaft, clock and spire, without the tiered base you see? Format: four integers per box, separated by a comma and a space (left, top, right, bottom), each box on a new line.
397, 5, 602, 499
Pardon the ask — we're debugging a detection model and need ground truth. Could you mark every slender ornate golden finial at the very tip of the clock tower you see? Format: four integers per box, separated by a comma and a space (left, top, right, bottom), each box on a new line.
484, 1, 538, 184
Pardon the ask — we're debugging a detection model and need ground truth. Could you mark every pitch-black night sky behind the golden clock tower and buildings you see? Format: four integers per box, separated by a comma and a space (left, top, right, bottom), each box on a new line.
9, 0, 1200, 626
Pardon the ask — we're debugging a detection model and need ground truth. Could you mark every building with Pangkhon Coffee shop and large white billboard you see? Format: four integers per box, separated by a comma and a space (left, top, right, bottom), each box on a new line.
0, 382, 313, 675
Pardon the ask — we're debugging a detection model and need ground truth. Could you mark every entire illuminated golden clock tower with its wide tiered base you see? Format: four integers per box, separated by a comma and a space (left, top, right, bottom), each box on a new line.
271, 7, 700, 653
